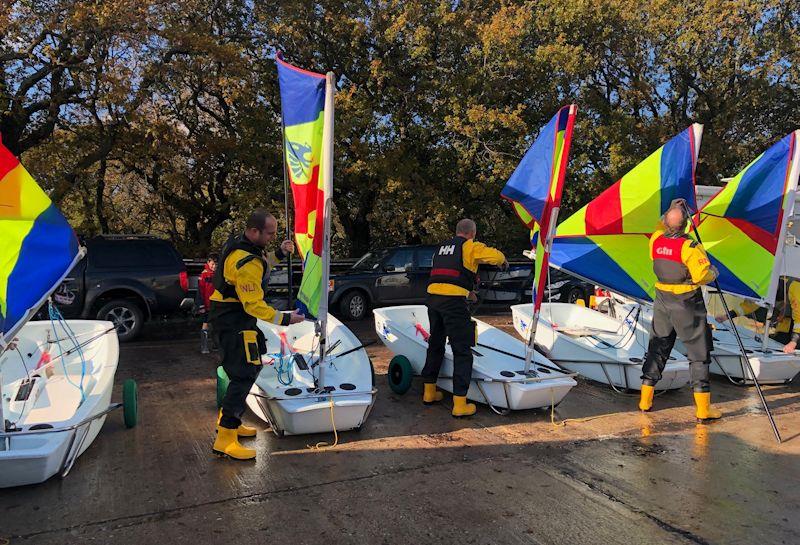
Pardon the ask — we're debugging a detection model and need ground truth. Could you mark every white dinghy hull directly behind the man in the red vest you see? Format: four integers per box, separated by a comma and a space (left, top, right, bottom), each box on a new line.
511, 303, 689, 390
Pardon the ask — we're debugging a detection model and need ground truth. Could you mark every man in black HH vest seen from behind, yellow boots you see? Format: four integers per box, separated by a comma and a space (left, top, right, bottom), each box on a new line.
422, 219, 508, 417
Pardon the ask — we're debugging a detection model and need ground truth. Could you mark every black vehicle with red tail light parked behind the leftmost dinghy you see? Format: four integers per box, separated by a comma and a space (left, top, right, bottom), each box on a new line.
53, 235, 192, 342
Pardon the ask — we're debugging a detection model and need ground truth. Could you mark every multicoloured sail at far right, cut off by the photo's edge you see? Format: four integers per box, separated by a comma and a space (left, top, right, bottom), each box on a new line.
698, 131, 800, 305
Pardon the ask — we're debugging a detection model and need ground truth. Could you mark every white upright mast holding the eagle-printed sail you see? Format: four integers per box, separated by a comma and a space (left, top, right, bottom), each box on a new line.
317, 72, 336, 389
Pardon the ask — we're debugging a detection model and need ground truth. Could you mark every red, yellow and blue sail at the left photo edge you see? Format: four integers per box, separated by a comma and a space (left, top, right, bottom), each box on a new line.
0, 141, 81, 348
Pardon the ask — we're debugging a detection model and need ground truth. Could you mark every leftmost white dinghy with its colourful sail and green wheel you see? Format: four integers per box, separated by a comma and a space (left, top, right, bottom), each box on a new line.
0, 138, 137, 488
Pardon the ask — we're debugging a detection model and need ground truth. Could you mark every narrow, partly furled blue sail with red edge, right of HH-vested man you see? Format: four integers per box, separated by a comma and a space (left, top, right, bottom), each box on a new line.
500, 104, 578, 316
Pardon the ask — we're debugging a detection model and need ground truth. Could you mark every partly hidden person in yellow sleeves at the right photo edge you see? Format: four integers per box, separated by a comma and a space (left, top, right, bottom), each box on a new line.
716, 276, 800, 354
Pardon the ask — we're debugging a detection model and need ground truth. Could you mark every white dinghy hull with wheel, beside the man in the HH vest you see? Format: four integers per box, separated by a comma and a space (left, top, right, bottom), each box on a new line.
373, 305, 577, 413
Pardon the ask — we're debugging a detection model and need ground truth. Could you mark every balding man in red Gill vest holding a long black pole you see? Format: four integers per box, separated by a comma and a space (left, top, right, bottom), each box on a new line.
639, 199, 722, 422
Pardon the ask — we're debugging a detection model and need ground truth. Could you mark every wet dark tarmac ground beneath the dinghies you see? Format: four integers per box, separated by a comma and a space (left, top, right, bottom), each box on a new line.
0, 314, 800, 545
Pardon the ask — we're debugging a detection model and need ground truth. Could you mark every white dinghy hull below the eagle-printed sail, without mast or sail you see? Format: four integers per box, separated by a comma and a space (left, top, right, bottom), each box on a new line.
247, 315, 377, 436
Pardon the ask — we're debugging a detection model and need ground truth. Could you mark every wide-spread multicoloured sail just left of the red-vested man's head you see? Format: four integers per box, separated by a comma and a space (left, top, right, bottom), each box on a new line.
550, 124, 703, 301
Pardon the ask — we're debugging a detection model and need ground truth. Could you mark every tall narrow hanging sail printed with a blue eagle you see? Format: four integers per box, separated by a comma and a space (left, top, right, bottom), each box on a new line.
276, 54, 326, 317
